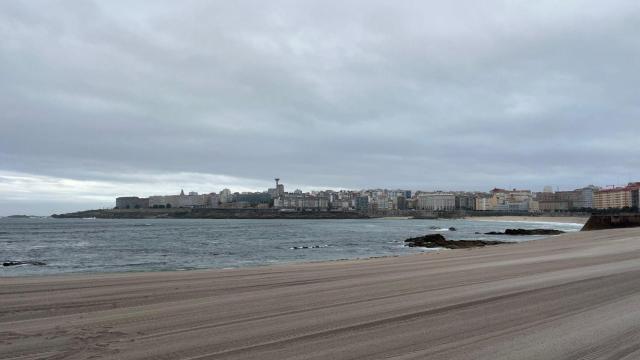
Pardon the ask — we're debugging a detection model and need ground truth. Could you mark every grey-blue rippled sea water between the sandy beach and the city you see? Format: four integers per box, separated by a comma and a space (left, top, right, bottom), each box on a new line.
0, 218, 582, 276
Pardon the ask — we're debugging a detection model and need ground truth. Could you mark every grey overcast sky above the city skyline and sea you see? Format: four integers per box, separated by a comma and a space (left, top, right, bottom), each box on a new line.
0, 0, 640, 215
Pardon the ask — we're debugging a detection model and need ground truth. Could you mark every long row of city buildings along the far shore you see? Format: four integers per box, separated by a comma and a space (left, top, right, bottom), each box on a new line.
116, 179, 640, 212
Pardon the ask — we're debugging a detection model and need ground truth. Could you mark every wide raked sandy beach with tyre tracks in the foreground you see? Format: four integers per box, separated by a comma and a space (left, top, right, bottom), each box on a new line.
0, 229, 640, 360
